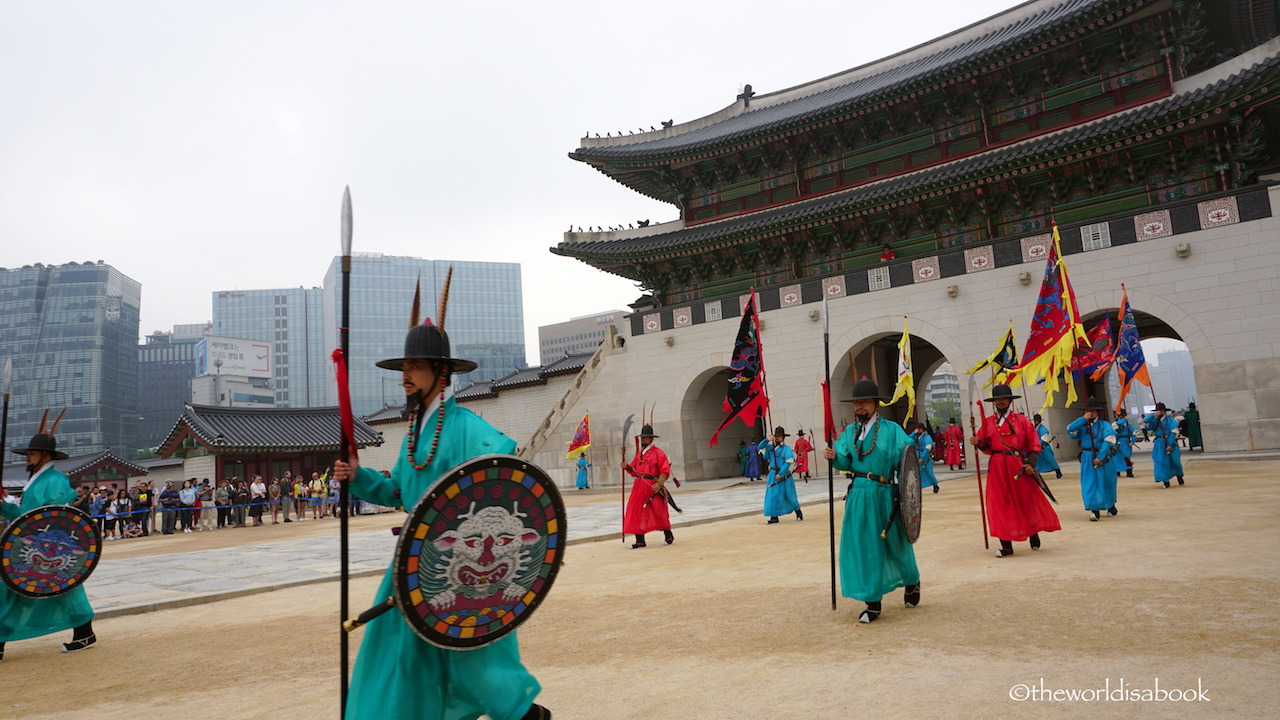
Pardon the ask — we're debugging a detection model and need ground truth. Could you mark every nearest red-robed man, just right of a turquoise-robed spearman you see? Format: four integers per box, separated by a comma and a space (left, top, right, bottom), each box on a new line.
970, 384, 1062, 557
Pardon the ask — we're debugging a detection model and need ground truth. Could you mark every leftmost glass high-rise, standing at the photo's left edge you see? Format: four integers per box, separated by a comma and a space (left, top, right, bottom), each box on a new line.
0, 261, 142, 457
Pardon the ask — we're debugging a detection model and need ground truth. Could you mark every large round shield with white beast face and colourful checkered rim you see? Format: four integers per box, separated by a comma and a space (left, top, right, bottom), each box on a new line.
393, 455, 567, 650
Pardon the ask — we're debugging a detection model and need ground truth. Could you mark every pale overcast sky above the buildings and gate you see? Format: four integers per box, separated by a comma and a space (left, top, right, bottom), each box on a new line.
0, 0, 1016, 363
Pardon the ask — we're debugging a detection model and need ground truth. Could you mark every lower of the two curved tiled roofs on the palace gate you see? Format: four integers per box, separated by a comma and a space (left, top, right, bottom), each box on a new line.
552, 49, 1280, 260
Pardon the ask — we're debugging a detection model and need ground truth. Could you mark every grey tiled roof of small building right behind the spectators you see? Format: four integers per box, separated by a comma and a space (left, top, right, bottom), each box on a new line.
159, 405, 383, 456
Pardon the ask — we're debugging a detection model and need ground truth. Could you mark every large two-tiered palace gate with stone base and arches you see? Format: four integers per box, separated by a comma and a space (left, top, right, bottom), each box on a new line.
525, 0, 1280, 478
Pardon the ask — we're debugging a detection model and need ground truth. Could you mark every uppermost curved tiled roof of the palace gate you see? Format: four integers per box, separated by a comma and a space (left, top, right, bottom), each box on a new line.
570, 0, 1121, 161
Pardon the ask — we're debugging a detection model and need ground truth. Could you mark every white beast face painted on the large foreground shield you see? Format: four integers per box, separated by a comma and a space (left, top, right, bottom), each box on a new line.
422, 503, 547, 611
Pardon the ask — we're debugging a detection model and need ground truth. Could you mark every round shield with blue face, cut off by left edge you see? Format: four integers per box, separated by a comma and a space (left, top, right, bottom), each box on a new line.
0, 505, 102, 597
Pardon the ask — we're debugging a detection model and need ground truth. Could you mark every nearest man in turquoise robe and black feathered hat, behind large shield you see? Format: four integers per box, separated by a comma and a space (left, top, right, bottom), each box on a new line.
334, 315, 550, 720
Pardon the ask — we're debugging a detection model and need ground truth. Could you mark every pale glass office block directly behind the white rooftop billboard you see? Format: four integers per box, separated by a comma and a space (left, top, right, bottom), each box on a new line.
209, 287, 327, 407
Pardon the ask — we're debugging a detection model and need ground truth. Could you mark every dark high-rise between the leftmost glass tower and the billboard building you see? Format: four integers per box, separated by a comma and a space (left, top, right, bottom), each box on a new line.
136, 323, 209, 450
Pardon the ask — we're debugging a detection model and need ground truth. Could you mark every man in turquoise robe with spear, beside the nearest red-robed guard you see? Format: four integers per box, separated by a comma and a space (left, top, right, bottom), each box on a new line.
823, 378, 920, 623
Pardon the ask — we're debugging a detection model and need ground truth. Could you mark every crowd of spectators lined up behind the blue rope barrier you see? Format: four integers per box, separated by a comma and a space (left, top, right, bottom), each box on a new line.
14, 471, 387, 541
